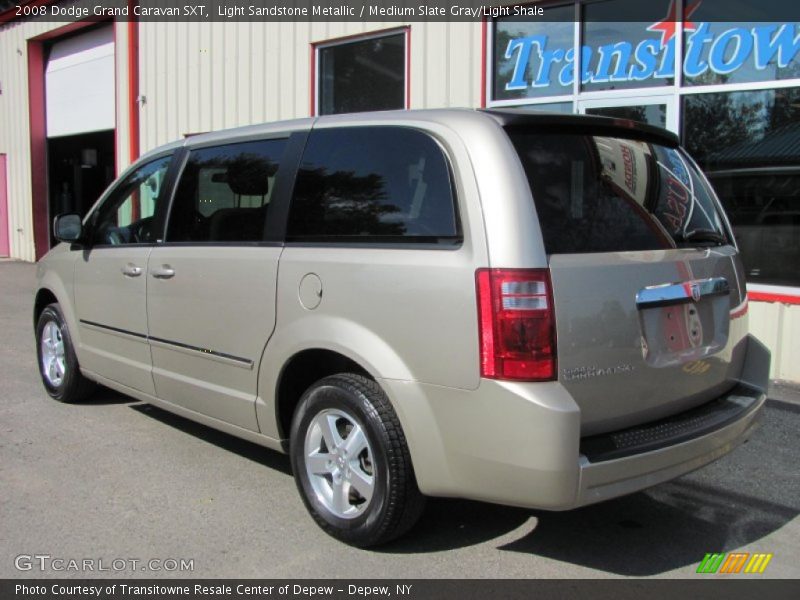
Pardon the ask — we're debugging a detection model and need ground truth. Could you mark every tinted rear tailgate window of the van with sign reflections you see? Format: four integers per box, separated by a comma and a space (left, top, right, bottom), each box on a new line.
509, 131, 729, 254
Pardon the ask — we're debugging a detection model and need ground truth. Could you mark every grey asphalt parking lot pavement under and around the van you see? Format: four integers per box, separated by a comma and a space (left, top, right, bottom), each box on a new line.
0, 262, 800, 578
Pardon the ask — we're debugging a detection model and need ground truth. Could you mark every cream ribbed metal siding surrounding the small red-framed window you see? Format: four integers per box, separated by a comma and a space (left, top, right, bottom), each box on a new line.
139, 22, 481, 152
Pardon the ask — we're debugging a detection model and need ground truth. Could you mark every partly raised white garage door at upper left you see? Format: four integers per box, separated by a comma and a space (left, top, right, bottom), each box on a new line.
45, 26, 115, 137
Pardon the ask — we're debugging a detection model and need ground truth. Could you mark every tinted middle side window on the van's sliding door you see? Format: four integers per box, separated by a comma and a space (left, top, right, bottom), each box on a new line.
166, 139, 286, 243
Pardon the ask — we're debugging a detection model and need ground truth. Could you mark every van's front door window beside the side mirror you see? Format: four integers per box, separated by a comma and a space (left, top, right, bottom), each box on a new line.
91, 156, 172, 246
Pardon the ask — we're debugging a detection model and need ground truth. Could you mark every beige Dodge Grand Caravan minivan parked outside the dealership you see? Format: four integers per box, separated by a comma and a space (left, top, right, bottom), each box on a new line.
34, 110, 770, 546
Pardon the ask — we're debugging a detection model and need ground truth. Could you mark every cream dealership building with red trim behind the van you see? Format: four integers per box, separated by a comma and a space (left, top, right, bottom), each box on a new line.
0, 0, 800, 382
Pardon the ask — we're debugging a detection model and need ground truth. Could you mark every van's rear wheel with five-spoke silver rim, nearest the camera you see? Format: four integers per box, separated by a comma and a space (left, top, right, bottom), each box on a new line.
290, 373, 425, 548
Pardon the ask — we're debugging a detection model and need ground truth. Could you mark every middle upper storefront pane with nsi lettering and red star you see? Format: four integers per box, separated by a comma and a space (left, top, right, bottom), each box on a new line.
581, 0, 676, 91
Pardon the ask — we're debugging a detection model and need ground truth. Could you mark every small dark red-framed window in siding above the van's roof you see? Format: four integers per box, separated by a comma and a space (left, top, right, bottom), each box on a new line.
317, 33, 406, 115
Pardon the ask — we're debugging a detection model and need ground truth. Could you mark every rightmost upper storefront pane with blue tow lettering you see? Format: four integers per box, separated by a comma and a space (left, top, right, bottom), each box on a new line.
683, 0, 800, 85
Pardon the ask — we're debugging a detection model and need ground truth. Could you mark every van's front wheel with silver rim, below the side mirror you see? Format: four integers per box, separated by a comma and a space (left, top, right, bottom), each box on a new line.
36, 303, 95, 402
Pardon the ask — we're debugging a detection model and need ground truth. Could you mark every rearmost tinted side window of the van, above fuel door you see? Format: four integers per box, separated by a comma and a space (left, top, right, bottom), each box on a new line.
287, 127, 460, 243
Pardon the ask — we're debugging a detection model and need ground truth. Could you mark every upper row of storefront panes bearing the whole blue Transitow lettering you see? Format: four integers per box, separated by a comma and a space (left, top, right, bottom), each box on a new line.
491, 0, 800, 101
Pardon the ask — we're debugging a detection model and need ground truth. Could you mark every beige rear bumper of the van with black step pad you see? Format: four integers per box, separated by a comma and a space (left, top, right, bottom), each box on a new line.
381, 332, 769, 510
